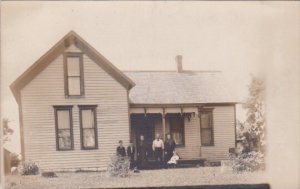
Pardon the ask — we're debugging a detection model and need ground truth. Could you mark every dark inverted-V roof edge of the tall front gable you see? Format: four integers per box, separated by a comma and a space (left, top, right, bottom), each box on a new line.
10, 31, 135, 102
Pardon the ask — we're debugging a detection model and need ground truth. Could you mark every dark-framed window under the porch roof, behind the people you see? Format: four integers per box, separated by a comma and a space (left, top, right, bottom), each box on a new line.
167, 113, 184, 146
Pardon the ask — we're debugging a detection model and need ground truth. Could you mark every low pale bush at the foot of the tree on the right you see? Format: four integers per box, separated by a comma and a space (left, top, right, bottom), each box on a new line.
230, 151, 264, 172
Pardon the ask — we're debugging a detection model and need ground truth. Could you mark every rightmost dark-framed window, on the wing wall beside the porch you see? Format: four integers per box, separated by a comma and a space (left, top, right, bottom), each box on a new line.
200, 111, 214, 146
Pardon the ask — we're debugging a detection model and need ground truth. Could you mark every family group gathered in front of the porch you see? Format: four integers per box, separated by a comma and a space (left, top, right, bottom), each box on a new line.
117, 134, 179, 169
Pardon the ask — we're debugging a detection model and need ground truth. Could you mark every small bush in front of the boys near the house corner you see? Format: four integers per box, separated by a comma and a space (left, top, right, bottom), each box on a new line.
107, 155, 130, 177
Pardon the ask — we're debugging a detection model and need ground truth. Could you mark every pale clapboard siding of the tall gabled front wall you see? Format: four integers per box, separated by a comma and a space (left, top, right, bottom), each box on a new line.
21, 46, 129, 170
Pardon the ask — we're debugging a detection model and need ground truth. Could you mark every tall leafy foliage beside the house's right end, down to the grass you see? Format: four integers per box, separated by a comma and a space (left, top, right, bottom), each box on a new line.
230, 76, 265, 172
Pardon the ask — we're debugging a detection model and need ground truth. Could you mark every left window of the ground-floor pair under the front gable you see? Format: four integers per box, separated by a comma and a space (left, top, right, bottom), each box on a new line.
54, 106, 73, 150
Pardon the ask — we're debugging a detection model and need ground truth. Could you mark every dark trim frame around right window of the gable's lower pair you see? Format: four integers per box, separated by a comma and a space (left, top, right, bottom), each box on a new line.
78, 105, 99, 150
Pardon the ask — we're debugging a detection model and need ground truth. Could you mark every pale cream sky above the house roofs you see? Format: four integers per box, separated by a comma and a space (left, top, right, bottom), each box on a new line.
1, 1, 291, 152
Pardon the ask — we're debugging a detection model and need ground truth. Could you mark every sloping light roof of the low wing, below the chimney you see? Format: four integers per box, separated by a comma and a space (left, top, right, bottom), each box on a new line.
124, 71, 238, 105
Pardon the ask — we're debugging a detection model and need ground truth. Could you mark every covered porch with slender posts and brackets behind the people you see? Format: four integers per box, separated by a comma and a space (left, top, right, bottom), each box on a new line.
130, 107, 204, 167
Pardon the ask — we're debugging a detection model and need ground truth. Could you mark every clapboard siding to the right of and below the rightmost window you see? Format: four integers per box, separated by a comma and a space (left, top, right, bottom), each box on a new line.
201, 105, 235, 160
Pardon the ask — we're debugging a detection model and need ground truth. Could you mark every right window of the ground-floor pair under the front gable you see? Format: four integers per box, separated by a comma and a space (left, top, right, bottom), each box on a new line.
78, 105, 98, 149
